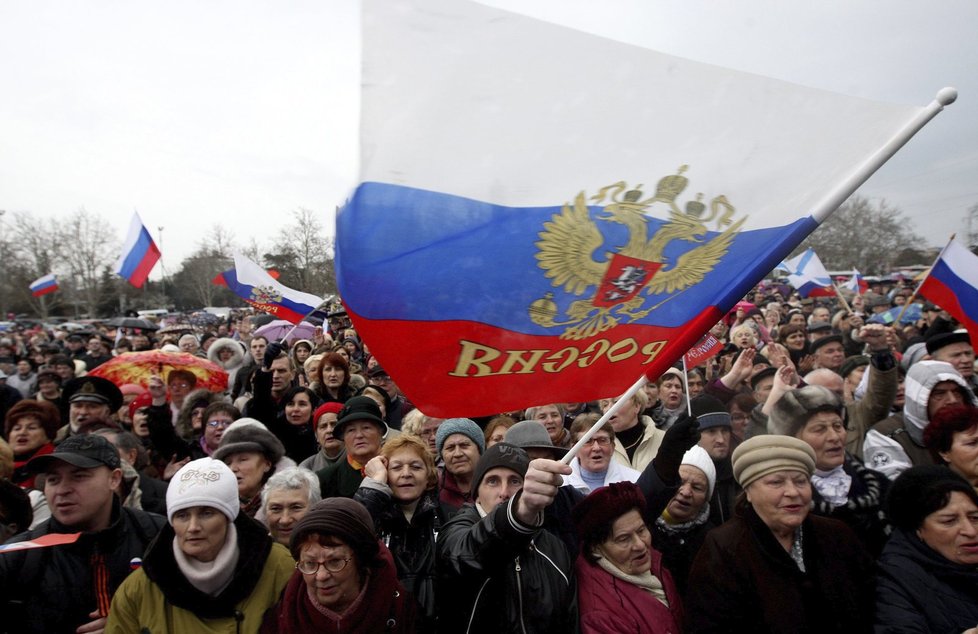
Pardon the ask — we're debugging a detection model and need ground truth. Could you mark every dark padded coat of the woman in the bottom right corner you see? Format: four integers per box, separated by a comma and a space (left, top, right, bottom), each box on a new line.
876, 530, 978, 634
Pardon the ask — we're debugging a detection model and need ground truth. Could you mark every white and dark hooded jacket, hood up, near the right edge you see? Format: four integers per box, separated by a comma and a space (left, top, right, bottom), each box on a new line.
863, 361, 978, 480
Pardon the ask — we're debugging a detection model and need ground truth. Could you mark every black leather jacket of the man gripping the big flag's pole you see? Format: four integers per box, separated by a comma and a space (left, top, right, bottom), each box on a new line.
438, 496, 579, 634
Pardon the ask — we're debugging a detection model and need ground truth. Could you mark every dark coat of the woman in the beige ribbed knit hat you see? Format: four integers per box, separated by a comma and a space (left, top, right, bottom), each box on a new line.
686, 506, 874, 634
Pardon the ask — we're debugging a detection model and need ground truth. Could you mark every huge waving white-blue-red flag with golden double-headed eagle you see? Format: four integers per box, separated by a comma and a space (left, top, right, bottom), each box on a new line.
336, 0, 953, 416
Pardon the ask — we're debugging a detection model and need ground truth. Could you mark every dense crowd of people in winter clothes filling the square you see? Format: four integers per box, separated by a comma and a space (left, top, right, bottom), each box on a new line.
0, 285, 978, 634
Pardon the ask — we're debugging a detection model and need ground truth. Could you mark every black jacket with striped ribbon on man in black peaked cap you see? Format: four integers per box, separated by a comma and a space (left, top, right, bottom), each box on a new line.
0, 499, 166, 634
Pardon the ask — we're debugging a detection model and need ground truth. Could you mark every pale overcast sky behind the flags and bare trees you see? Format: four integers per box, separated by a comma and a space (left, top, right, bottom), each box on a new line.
0, 0, 978, 277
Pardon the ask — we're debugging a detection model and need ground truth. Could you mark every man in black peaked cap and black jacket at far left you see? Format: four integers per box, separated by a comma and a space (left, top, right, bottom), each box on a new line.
0, 434, 166, 632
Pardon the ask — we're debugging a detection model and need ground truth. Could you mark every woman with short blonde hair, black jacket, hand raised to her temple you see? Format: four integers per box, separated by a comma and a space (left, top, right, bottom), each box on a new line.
353, 434, 446, 632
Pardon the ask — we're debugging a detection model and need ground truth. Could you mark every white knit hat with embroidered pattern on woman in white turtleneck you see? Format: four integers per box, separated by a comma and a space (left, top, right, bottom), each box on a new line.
166, 458, 241, 524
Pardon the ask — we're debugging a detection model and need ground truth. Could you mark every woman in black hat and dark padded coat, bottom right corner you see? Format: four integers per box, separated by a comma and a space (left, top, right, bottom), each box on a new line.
876, 465, 978, 634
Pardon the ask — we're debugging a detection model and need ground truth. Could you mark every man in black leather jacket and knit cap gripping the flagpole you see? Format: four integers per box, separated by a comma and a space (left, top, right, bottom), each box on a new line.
438, 442, 579, 634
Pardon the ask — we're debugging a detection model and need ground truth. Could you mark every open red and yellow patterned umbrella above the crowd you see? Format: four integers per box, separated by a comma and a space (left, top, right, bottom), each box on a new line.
88, 350, 228, 392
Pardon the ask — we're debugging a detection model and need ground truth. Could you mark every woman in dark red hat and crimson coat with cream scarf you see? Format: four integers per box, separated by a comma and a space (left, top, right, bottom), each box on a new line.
573, 482, 683, 634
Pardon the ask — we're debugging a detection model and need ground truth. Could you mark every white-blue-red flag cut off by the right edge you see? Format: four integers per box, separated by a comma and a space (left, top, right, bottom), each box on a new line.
917, 240, 978, 349
